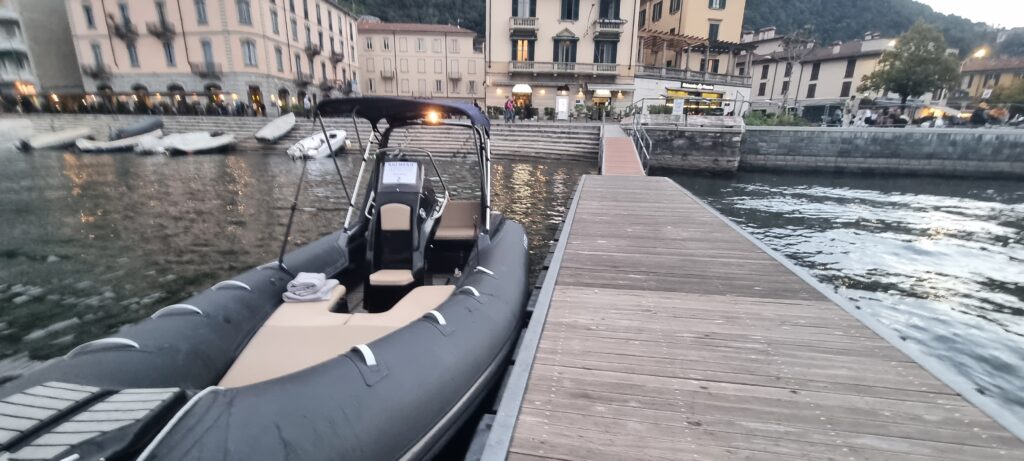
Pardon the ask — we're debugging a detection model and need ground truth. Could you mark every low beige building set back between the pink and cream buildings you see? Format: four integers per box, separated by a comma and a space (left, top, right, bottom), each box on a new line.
358, 16, 484, 104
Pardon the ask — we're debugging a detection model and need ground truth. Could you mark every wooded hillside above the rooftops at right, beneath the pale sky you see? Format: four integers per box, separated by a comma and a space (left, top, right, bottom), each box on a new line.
743, 0, 995, 55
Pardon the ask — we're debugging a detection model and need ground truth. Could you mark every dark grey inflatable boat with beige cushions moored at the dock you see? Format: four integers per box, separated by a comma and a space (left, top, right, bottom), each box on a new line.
0, 97, 528, 461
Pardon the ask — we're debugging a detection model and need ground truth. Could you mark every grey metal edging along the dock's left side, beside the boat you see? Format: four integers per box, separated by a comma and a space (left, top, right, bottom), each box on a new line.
480, 176, 587, 461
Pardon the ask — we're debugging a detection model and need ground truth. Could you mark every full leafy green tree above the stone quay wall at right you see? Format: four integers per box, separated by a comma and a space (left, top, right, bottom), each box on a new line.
857, 20, 959, 104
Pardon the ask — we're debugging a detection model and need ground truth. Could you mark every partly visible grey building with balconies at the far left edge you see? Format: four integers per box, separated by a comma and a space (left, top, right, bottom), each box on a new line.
0, 0, 82, 109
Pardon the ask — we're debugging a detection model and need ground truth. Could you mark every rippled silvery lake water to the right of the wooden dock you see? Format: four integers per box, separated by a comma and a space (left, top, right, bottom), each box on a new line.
675, 173, 1024, 421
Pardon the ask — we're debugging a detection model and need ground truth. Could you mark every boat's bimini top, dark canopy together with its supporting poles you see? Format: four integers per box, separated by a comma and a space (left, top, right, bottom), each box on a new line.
316, 97, 490, 234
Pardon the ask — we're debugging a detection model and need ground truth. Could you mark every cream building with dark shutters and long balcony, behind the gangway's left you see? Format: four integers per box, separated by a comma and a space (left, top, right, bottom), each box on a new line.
485, 0, 638, 119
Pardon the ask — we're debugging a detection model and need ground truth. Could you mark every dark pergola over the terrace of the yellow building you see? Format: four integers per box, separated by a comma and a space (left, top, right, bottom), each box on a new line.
638, 31, 755, 75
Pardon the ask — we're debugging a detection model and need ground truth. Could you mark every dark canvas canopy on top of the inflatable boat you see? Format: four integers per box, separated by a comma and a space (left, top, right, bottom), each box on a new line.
316, 97, 490, 135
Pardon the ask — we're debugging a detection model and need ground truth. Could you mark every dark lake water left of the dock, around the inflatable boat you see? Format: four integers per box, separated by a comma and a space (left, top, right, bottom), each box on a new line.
0, 151, 593, 382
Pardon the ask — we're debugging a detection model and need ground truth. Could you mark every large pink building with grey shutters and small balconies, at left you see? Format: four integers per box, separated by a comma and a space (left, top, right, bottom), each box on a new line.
67, 0, 358, 109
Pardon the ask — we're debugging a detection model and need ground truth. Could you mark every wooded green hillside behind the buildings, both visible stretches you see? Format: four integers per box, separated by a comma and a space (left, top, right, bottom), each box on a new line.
341, 0, 994, 54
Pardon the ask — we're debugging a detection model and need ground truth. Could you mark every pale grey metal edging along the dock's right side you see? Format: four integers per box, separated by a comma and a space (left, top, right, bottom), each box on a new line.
665, 178, 1024, 439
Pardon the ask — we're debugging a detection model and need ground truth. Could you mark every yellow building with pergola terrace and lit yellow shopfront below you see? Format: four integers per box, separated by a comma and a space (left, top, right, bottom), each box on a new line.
636, 0, 753, 115
